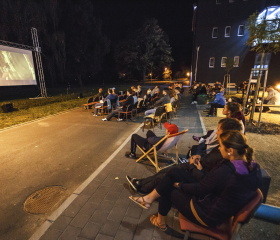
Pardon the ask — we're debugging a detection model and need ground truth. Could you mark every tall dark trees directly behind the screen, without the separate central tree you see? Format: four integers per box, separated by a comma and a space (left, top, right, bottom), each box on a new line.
0, 0, 110, 87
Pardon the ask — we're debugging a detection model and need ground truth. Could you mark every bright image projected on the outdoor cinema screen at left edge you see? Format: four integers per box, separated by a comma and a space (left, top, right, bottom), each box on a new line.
0, 45, 37, 86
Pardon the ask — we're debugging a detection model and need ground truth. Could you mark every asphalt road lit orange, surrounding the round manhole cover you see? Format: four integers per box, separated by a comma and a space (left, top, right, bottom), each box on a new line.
0, 109, 139, 240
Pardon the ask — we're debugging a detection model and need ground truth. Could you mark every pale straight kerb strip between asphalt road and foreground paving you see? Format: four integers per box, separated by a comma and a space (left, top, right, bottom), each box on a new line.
29, 124, 142, 240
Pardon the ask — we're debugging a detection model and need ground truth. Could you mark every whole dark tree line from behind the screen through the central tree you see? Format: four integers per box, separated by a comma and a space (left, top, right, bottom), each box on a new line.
0, 0, 173, 87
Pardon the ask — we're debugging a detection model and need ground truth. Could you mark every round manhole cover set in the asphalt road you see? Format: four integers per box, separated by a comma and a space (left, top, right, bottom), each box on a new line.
23, 186, 67, 214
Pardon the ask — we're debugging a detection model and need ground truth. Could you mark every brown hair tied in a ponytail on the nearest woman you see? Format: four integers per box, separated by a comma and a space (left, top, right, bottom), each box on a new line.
219, 131, 254, 168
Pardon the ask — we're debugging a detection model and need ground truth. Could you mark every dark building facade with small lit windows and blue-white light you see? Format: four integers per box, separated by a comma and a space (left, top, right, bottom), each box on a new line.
192, 0, 280, 84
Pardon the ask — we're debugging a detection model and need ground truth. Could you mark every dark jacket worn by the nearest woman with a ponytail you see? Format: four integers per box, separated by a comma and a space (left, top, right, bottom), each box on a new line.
180, 160, 262, 227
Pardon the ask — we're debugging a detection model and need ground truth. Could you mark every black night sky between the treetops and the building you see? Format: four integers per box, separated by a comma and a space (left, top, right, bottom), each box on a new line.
92, 0, 193, 70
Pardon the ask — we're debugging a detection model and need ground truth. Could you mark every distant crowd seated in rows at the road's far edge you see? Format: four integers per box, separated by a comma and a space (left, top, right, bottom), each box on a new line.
86, 84, 183, 121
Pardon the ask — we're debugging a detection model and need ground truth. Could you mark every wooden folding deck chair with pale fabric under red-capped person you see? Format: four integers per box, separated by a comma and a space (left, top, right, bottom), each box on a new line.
136, 129, 188, 172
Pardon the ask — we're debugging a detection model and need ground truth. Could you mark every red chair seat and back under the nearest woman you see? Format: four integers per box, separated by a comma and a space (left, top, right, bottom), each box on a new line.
179, 189, 263, 240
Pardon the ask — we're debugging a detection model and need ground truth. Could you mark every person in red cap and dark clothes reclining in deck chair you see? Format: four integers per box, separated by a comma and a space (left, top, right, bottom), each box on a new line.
125, 122, 178, 159
